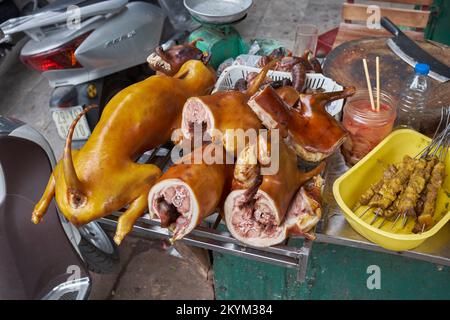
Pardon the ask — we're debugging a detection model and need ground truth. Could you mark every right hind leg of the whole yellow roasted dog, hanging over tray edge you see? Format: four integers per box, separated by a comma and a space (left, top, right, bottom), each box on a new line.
114, 192, 148, 245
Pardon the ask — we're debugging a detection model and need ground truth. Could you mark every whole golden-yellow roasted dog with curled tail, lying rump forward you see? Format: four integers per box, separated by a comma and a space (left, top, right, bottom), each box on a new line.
32, 46, 215, 244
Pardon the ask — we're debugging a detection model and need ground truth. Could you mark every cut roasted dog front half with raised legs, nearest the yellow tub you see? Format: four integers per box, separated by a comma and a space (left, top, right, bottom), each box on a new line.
224, 141, 324, 247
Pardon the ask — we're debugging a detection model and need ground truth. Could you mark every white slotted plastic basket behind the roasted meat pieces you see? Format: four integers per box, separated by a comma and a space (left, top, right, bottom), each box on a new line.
213, 65, 344, 116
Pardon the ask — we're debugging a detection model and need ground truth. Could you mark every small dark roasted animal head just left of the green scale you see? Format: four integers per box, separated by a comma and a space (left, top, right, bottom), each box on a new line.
147, 39, 210, 76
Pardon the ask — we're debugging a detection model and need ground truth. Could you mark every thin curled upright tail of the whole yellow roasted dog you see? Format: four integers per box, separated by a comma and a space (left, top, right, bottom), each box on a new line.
63, 104, 98, 209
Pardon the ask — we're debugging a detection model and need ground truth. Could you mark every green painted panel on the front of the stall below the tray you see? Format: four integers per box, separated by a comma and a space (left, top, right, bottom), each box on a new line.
213, 243, 450, 299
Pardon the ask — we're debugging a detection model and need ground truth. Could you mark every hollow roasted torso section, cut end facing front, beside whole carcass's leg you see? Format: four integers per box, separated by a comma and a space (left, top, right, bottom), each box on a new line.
148, 144, 232, 241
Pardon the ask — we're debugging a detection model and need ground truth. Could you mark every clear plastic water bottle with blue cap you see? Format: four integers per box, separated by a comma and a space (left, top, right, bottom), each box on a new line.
396, 63, 430, 131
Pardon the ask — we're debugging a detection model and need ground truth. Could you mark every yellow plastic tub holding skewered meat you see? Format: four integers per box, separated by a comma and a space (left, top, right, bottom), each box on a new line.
333, 129, 450, 251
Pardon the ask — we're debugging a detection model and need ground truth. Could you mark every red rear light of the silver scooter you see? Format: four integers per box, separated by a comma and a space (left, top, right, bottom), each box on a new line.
20, 32, 90, 72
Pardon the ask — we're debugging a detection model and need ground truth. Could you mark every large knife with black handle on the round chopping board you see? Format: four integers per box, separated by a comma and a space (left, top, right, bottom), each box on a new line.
380, 17, 450, 82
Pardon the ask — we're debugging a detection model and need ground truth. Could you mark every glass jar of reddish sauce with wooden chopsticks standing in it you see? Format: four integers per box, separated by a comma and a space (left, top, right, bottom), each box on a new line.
342, 90, 397, 166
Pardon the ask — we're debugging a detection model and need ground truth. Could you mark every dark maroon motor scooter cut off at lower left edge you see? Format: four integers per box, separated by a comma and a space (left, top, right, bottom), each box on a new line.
0, 116, 119, 300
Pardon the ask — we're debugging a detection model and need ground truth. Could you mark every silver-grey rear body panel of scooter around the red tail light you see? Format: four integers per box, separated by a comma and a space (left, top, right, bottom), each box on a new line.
21, 2, 165, 87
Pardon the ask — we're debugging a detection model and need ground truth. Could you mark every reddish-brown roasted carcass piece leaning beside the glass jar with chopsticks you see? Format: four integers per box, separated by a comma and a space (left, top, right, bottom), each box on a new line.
248, 86, 355, 162
